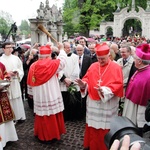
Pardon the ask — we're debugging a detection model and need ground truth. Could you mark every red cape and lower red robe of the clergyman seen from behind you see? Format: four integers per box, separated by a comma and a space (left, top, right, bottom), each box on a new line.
27, 58, 66, 141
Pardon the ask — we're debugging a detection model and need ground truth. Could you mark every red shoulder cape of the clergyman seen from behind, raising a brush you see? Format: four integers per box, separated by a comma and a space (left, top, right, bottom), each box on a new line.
27, 58, 60, 86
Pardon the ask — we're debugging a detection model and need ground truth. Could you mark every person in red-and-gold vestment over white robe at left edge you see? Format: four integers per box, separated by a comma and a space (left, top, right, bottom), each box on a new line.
0, 62, 18, 147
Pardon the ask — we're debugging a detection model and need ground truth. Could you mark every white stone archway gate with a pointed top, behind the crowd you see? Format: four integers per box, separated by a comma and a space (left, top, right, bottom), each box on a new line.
100, 2, 150, 39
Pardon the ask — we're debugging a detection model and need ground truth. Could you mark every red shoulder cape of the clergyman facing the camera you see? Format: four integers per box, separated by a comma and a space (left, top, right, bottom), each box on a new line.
82, 61, 123, 100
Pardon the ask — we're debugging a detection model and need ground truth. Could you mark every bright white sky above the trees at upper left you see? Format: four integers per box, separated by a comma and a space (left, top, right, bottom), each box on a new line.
0, 0, 64, 25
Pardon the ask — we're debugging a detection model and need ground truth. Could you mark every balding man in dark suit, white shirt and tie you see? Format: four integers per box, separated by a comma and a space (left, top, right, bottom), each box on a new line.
76, 44, 91, 79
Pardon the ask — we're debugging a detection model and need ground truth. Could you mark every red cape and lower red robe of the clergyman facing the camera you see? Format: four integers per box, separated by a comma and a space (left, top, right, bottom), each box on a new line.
82, 60, 123, 150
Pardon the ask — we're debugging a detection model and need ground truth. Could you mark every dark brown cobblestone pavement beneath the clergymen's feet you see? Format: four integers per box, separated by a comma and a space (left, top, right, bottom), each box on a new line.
4, 101, 85, 150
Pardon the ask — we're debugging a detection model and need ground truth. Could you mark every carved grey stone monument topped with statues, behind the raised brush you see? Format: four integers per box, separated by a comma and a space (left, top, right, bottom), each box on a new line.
29, 0, 63, 44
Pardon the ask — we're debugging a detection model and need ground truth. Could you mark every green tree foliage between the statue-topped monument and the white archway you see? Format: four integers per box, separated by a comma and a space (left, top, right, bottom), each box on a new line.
63, 0, 147, 36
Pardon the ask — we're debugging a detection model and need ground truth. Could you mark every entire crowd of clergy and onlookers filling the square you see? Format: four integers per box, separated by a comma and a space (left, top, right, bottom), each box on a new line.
0, 37, 150, 150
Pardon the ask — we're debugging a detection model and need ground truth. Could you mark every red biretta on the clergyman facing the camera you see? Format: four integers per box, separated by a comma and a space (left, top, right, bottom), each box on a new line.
95, 43, 110, 56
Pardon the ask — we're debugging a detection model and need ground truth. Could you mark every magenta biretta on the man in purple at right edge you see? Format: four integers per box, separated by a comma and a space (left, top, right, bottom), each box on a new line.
135, 44, 150, 60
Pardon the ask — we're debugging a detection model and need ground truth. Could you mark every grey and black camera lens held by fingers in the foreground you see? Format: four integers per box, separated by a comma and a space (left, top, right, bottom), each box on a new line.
105, 116, 150, 150
